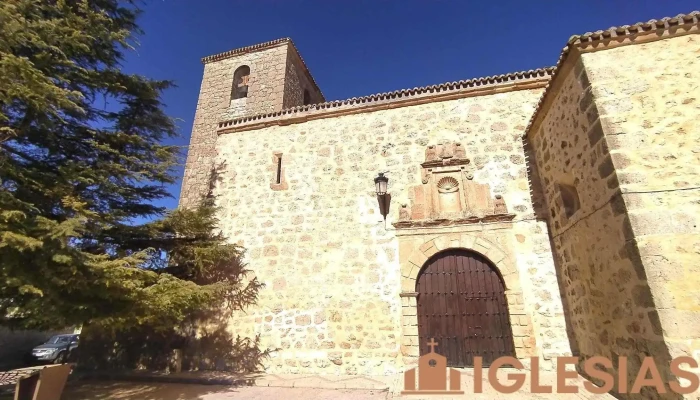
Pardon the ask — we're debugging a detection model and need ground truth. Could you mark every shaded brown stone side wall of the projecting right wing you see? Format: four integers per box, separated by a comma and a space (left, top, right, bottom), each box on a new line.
530, 54, 680, 398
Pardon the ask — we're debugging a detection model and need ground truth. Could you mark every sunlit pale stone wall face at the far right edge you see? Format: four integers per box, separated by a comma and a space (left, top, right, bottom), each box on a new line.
584, 34, 700, 398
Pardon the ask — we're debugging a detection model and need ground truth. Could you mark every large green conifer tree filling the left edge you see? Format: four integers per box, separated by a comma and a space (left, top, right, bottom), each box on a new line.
0, 0, 259, 329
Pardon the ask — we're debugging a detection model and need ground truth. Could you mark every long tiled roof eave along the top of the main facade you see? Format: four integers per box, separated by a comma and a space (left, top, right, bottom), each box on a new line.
218, 67, 553, 133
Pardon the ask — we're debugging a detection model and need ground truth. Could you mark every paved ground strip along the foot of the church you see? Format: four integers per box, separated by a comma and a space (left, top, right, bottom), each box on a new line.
63, 370, 613, 400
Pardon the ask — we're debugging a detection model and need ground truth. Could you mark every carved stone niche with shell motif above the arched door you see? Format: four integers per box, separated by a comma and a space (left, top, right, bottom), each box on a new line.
393, 143, 515, 228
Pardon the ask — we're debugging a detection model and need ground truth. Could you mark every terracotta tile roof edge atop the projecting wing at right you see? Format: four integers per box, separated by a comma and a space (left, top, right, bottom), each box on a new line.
525, 11, 700, 136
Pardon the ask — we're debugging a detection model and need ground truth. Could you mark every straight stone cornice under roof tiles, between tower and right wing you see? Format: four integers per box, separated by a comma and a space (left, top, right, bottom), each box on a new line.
218, 67, 553, 134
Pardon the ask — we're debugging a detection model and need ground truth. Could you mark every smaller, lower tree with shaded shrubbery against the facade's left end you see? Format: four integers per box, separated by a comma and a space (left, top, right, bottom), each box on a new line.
78, 200, 271, 372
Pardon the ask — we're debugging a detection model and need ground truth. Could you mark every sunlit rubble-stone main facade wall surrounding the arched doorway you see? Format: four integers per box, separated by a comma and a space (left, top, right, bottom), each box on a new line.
215, 90, 569, 374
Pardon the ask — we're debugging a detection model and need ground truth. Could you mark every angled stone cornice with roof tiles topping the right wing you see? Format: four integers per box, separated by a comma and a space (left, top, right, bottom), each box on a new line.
524, 11, 700, 137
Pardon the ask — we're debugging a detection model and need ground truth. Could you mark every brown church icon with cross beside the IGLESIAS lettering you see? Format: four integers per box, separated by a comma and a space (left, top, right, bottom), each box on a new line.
401, 338, 464, 395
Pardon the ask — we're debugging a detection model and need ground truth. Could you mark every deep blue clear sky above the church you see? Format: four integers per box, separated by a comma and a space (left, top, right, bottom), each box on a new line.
124, 0, 700, 216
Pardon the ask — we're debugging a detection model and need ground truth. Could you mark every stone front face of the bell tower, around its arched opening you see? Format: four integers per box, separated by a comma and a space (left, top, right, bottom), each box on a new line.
180, 44, 288, 207
